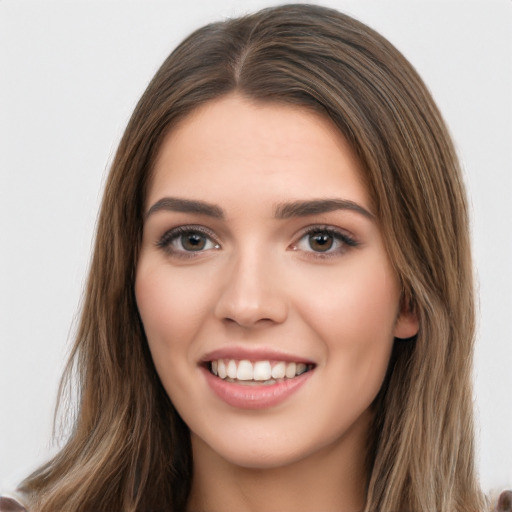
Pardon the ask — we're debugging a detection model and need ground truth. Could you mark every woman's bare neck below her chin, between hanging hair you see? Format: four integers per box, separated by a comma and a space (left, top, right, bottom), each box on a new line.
188, 410, 367, 512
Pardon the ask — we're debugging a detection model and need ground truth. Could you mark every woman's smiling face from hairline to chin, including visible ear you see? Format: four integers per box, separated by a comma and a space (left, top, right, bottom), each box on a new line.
136, 95, 417, 468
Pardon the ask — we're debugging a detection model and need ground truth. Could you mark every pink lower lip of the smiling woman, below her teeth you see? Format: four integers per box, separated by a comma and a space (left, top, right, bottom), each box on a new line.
202, 368, 313, 409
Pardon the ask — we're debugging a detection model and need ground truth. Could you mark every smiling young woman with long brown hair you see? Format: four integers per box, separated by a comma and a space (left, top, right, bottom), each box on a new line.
3, 5, 508, 511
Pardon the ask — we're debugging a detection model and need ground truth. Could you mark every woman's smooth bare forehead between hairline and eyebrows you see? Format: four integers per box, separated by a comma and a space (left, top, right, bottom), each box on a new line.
147, 94, 371, 212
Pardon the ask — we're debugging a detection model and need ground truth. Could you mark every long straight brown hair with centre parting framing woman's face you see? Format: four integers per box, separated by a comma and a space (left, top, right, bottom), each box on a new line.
23, 5, 485, 512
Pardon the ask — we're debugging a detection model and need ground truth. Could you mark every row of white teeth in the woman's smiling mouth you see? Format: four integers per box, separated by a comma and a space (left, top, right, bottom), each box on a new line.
210, 359, 311, 384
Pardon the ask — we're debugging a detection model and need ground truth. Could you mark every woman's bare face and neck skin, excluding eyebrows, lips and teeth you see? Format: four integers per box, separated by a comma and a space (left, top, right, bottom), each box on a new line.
136, 94, 418, 512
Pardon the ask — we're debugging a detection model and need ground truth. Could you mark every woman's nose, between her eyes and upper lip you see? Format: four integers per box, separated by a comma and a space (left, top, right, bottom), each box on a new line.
215, 249, 288, 328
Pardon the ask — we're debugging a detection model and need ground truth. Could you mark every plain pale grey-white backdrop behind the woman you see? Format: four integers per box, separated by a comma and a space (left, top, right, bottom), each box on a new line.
0, 0, 512, 498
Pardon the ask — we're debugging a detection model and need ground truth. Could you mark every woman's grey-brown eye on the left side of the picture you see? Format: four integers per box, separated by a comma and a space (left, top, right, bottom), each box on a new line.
157, 226, 220, 257
